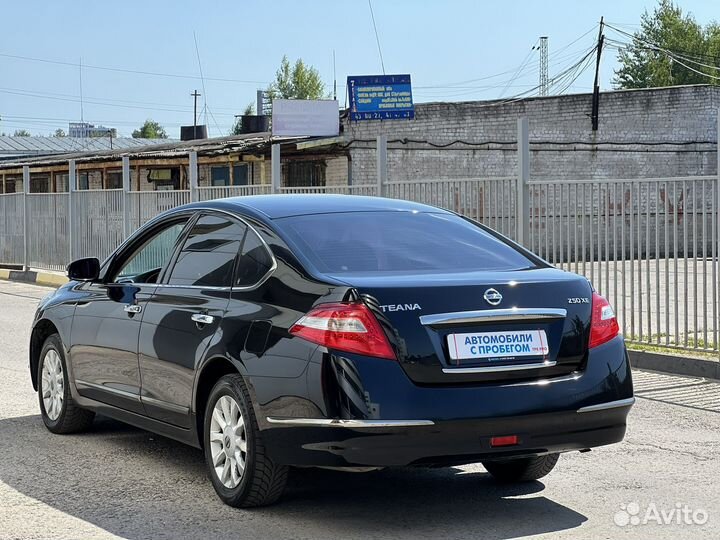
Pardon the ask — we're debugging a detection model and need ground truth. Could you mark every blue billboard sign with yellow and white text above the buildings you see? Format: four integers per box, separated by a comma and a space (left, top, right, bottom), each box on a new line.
348, 75, 415, 120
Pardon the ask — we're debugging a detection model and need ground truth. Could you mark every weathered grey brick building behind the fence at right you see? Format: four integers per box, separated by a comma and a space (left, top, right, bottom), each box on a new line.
344, 85, 720, 184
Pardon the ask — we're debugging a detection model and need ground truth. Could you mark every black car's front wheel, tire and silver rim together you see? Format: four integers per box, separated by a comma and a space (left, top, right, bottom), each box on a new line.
37, 334, 95, 434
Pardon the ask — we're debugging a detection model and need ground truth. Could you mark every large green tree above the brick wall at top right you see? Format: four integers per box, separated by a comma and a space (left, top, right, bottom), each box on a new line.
613, 0, 720, 88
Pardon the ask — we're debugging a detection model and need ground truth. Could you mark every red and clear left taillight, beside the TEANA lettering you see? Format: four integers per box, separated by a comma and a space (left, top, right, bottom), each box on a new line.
290, 302, 396, 360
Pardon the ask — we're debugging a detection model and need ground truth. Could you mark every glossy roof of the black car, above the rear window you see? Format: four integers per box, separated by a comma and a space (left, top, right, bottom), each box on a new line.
178, 194, 448, 219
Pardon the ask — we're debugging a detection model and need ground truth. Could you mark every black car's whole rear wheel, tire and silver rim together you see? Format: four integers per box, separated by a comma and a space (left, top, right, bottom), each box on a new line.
203, 374, 288, 508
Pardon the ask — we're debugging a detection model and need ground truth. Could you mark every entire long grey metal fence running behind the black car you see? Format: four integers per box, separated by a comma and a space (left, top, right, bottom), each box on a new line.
0, 127, 720, 354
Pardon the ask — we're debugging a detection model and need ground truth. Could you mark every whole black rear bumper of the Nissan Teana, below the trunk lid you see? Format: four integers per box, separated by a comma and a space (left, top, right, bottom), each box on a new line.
262, 337, 634, 467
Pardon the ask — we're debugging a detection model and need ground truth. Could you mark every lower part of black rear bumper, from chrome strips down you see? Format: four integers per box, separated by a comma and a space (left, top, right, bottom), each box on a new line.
265, 398, 635, 467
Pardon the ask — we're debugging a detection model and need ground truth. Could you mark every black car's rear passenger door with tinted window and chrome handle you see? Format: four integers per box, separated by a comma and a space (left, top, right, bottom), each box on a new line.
139, 213, 247, 428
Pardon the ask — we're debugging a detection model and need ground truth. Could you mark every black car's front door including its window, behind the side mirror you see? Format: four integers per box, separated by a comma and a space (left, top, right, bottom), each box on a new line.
70, 217, 187, 413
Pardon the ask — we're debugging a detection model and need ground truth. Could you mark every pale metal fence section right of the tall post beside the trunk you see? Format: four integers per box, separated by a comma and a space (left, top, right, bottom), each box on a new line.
528, 176, 720, 352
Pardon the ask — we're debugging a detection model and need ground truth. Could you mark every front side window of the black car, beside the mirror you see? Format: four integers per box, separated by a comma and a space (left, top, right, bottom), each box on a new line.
112, 219, 187, 283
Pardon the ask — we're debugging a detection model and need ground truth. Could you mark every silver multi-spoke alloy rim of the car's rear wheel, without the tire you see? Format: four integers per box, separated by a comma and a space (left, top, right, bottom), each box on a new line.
210, 395, 247, 489
